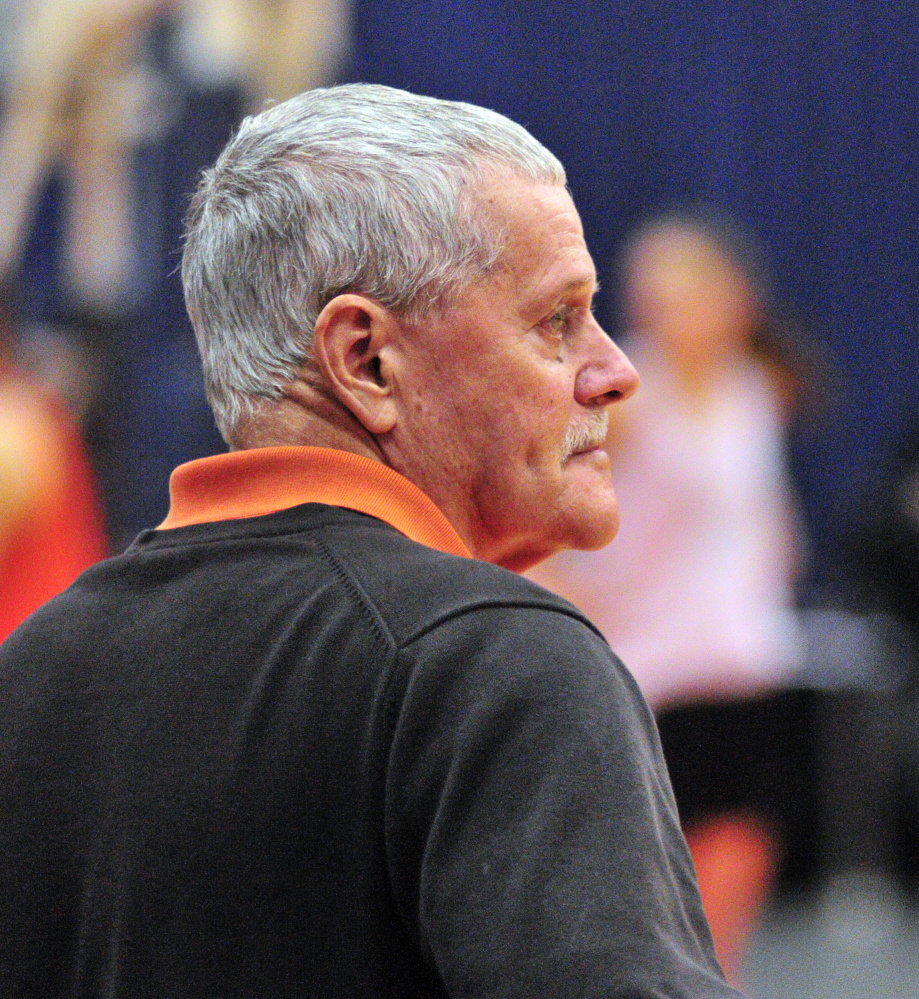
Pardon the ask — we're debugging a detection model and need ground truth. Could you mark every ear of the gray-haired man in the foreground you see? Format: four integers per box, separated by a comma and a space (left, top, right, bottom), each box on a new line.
313, 294, 400, 434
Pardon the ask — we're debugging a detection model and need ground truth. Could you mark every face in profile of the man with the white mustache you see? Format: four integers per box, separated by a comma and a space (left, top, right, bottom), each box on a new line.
392, 175, 638, 571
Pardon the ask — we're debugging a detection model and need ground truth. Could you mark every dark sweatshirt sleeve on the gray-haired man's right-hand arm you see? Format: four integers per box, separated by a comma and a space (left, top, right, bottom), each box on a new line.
386, 607, 738, 999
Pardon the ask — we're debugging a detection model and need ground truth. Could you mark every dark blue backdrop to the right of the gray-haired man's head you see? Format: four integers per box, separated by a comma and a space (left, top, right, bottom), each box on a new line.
349, 0, 919, 586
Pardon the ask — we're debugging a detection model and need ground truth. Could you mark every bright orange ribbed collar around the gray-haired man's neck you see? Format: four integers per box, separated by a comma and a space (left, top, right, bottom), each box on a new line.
159, 447, 471, 558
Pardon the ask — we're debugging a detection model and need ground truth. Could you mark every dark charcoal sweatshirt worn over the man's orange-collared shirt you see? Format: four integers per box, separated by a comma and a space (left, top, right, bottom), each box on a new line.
0, 503, 736, 999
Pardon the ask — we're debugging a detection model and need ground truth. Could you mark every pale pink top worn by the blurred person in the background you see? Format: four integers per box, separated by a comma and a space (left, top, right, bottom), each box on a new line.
531, 340, 801, 707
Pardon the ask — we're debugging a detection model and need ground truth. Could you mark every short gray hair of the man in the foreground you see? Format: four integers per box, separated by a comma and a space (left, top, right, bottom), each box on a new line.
182, 84, 565, 441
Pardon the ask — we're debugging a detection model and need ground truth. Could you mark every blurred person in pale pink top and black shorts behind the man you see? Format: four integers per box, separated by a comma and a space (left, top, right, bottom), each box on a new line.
531, 208, 803, 982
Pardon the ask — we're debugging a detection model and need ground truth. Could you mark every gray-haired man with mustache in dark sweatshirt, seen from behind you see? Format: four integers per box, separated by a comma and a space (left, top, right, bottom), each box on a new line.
0, 86, 736, 999
